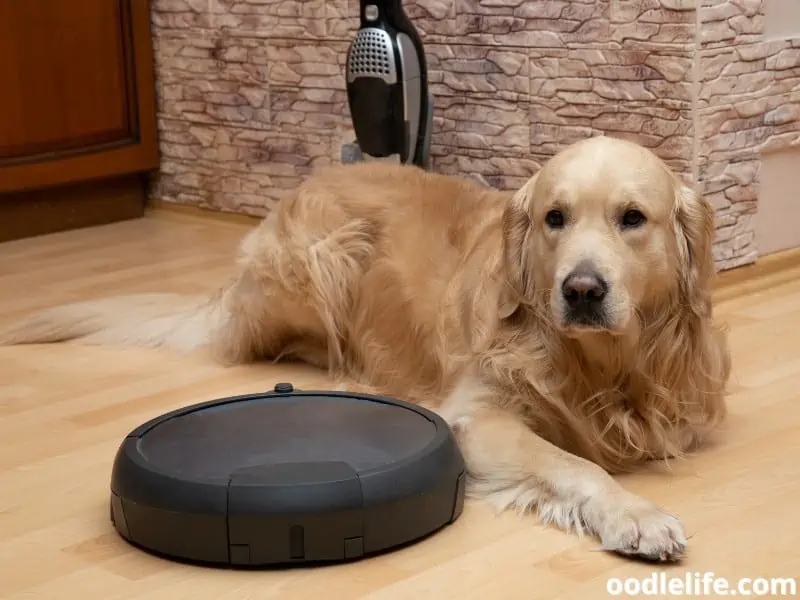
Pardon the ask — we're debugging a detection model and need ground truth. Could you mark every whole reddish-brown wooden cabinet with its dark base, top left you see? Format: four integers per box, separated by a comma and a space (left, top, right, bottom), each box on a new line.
0, 0, 158, 240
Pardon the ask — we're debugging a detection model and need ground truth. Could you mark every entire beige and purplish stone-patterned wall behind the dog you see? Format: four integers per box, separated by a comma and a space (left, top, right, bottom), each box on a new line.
151, 0, 800, 268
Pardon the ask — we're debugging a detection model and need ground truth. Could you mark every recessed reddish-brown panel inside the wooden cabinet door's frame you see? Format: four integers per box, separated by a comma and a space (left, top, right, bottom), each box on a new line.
0, 0, 132, 160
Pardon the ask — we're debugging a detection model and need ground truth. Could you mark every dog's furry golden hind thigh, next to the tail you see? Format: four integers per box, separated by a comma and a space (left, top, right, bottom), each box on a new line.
211, 192, 374, 371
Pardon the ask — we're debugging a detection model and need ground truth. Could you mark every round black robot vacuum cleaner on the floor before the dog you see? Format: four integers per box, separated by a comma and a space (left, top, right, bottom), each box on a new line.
111, 383, 466, 567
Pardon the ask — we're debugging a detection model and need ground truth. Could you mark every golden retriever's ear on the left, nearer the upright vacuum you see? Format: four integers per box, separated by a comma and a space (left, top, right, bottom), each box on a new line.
500, 173, 538, 310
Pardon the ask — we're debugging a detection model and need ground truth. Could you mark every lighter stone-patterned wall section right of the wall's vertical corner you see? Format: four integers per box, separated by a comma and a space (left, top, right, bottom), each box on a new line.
696, 0, 800, 268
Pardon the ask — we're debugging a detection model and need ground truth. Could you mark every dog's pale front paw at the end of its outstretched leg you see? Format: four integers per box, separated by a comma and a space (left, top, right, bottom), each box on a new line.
598, 502, 686, 562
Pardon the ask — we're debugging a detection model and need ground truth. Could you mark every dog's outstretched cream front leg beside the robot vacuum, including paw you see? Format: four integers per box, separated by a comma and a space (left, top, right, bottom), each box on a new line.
438, 382, 686, 562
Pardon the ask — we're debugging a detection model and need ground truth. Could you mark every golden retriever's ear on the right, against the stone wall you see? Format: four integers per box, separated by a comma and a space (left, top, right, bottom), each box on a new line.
673, 177, 715, 316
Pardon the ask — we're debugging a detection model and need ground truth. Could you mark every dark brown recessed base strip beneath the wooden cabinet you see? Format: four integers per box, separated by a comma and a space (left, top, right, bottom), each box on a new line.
0, 175, 147, 242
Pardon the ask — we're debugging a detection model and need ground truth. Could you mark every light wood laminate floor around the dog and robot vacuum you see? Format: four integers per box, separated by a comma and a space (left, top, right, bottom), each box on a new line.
0, 213, 800, 600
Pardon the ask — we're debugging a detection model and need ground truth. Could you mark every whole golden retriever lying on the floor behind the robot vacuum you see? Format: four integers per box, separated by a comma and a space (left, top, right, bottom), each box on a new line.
0, 136, 731, 562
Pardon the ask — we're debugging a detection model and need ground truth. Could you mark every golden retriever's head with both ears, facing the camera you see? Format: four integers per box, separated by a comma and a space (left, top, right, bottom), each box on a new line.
504, 137, 714, 337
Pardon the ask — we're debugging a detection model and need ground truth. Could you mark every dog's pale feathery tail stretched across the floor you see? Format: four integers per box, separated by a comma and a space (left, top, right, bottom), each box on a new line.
0, 294, 219, 352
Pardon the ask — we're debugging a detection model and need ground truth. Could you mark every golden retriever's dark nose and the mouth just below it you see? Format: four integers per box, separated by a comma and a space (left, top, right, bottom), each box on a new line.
561, 261, 608, 328
